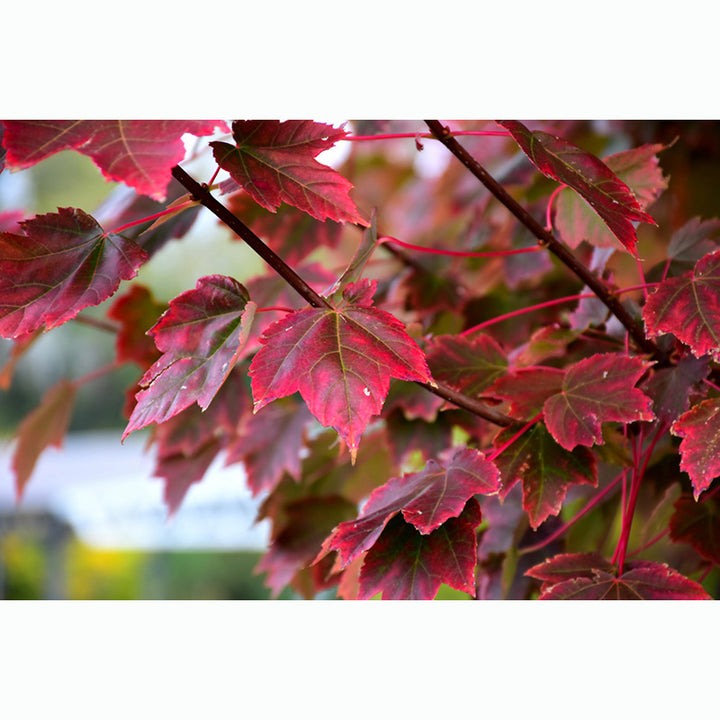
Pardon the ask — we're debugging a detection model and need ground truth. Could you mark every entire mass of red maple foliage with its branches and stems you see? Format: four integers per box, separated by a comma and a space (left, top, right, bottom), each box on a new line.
0, 120, 720, 600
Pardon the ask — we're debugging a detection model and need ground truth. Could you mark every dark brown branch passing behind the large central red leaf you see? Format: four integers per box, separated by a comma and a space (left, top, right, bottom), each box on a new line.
172, 165, 516, 427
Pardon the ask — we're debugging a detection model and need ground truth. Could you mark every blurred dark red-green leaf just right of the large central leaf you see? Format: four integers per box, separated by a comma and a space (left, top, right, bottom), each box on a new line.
426, 333, 508, 397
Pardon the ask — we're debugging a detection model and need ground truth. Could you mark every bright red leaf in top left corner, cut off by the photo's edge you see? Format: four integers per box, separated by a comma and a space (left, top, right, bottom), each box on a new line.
3, 120, 228, 200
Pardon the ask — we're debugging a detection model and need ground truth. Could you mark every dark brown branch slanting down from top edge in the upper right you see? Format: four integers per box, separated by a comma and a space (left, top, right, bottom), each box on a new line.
425, 120, 665, 366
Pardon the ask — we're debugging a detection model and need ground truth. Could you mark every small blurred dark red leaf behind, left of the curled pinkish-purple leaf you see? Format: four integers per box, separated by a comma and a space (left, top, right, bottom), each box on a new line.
108, 285, 167, 368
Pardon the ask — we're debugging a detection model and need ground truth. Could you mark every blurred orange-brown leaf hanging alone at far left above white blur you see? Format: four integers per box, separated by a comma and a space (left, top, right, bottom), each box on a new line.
12, 380, 77, 500
